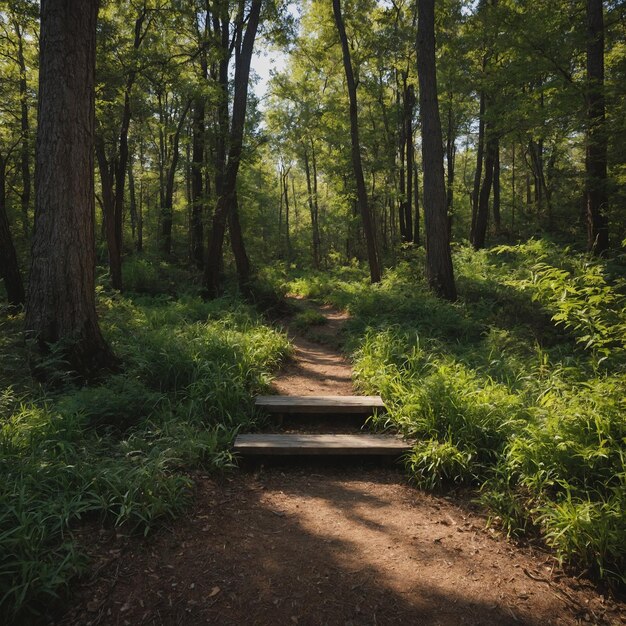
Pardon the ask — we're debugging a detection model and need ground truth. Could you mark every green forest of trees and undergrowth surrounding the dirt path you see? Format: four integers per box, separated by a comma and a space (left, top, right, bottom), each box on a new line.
0, 0, 626, 623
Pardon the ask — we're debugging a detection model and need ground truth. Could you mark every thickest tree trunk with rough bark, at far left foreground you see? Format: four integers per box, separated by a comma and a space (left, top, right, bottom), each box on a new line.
26, 0, 113, 377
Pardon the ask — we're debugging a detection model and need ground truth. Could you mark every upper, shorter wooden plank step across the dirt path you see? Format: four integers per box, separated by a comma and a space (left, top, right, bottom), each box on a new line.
255, 396, 385, 413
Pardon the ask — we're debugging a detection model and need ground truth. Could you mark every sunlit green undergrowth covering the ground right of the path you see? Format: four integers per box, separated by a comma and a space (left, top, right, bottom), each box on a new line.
272, 240, 626, 584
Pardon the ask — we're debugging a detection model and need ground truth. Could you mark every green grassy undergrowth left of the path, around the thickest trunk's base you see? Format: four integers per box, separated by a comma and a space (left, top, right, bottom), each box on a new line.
0, 266, 288, 622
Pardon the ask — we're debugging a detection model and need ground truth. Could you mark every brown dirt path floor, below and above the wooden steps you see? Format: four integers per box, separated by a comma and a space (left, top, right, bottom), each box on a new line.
60, 298, 626, 626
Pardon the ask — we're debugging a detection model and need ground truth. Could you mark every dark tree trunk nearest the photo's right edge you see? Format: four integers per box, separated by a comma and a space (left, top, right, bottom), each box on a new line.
585, 0, 609, 255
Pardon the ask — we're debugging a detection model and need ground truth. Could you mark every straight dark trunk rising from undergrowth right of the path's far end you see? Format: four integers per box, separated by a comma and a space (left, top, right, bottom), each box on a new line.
417, 0, 456, 300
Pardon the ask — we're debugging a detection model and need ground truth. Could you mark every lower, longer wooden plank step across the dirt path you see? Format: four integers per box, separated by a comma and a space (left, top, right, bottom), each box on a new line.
234, 433, 411, 456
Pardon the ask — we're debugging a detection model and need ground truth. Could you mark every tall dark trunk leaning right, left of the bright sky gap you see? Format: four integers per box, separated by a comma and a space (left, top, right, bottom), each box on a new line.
203, 0, 262, 297
